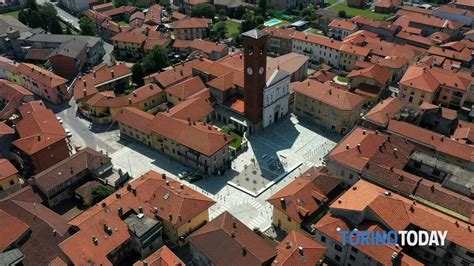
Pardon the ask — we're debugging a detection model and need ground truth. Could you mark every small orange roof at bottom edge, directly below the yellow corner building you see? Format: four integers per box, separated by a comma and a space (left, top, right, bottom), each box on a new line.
272, 231, 327, 266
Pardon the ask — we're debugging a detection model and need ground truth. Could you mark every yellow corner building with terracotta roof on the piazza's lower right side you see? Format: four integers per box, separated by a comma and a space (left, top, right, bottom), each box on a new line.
267, 167, 343, 233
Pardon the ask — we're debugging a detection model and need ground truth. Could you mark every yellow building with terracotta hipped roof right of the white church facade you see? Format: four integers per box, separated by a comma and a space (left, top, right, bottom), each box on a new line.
293, 79, 364, 133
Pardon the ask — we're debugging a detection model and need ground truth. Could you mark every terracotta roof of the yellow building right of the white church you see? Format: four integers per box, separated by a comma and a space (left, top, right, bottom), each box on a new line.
292, 79, 364, 111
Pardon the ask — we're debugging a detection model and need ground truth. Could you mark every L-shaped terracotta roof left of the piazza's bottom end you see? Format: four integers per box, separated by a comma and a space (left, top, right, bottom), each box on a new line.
59, 171, 215, 265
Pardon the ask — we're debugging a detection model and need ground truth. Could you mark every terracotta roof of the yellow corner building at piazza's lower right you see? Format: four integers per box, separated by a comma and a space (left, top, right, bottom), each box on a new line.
267, 167, 342, 223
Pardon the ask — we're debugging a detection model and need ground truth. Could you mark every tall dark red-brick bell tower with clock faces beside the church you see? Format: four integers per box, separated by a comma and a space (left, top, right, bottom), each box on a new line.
242, 29, 268, 131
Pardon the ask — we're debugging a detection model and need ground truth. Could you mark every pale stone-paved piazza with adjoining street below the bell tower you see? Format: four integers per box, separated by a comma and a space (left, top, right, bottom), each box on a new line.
65, 111, 341, 231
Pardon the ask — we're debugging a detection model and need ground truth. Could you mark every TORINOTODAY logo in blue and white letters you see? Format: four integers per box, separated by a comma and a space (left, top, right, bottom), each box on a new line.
337, 228, 448, 247
